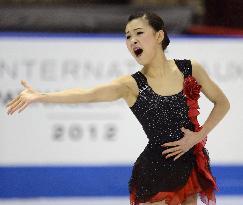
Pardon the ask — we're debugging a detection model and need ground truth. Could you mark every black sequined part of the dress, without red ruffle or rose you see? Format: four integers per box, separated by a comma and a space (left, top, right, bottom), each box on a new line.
129, 60, 217, 205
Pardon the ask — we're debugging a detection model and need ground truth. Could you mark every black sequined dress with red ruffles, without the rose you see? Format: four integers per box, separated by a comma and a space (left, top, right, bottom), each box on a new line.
129, 60, 216, 205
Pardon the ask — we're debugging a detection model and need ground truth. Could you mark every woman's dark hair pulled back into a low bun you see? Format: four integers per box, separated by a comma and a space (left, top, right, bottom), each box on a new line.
127, 12, 170, 50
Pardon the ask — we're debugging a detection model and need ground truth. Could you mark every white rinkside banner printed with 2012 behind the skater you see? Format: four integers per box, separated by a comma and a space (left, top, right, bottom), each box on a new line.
0, 33, 243, 165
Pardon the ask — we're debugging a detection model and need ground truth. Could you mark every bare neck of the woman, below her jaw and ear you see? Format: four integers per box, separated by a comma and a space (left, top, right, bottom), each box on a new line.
143, 51, 169, 78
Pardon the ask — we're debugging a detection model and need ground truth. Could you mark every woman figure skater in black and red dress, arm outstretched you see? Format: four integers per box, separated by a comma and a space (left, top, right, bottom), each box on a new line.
7, 13, 230, 205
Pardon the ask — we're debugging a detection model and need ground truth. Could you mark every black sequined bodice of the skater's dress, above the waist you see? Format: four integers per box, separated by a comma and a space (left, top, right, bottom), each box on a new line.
130, 60, 194, 147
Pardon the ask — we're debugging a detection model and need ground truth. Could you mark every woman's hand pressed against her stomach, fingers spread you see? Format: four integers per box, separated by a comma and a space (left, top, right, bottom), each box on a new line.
161, 127, 201, 160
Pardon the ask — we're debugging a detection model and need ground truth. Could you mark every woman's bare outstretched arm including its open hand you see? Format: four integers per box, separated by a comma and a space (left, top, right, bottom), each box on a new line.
6, 76, 129, 114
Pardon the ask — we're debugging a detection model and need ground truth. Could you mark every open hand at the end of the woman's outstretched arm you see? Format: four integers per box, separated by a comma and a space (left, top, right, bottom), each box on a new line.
6, 80, 41, 115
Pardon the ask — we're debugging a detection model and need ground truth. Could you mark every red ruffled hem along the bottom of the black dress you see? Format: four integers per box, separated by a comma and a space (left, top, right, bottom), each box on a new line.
130, 168, 216, 205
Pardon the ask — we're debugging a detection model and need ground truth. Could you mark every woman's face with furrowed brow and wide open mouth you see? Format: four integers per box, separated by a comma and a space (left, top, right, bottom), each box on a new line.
125, 18, 163, 65
